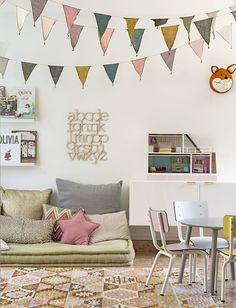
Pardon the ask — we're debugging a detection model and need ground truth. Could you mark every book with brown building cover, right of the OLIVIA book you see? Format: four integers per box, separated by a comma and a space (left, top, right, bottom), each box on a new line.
12, 130, 37, 163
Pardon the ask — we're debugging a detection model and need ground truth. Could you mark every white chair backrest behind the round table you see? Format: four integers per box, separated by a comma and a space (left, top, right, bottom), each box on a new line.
174, 201, 208, 241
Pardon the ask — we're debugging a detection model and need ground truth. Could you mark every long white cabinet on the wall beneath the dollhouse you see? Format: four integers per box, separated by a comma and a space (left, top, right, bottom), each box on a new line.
129, 180, 236, 226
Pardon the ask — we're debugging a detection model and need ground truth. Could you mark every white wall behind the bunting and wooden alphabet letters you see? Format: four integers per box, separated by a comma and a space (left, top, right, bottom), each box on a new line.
0, 0, 236, 238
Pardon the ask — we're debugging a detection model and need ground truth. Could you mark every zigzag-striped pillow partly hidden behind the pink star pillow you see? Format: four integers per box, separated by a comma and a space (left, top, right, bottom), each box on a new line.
42, 204, 79, 241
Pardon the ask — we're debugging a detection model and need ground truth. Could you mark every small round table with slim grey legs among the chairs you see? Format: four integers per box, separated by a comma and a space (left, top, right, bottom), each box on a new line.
179, 217, 227, 295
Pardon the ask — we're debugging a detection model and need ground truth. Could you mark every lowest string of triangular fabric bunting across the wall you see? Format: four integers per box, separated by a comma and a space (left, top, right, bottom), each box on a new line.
0, 22, 232, 88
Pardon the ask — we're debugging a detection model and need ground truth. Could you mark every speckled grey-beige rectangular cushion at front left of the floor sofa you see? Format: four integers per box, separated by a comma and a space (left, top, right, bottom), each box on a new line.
0, 215, 55, 244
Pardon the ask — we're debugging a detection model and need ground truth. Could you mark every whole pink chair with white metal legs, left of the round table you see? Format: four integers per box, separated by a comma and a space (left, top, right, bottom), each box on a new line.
145, 209, 207, 296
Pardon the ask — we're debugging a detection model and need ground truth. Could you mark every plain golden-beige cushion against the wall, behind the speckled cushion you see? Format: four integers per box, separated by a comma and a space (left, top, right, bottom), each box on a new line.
0, 187, 52, 219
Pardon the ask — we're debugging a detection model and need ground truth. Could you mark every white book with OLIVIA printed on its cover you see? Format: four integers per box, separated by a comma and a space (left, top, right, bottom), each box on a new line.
0, 133, 21, 165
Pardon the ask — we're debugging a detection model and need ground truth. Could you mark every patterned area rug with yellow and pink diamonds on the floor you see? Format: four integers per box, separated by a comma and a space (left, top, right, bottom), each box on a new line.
0, 267, 218, 308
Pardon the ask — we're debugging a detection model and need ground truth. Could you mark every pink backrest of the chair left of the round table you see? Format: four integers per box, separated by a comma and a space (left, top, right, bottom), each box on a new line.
148, 209, 170, 250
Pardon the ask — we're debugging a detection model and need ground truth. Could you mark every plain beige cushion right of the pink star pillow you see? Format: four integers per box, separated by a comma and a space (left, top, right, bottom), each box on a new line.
86, 211, 130, 244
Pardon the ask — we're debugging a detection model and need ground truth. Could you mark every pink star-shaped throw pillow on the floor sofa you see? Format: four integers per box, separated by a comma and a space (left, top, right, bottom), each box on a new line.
57, 209, 100, 245
